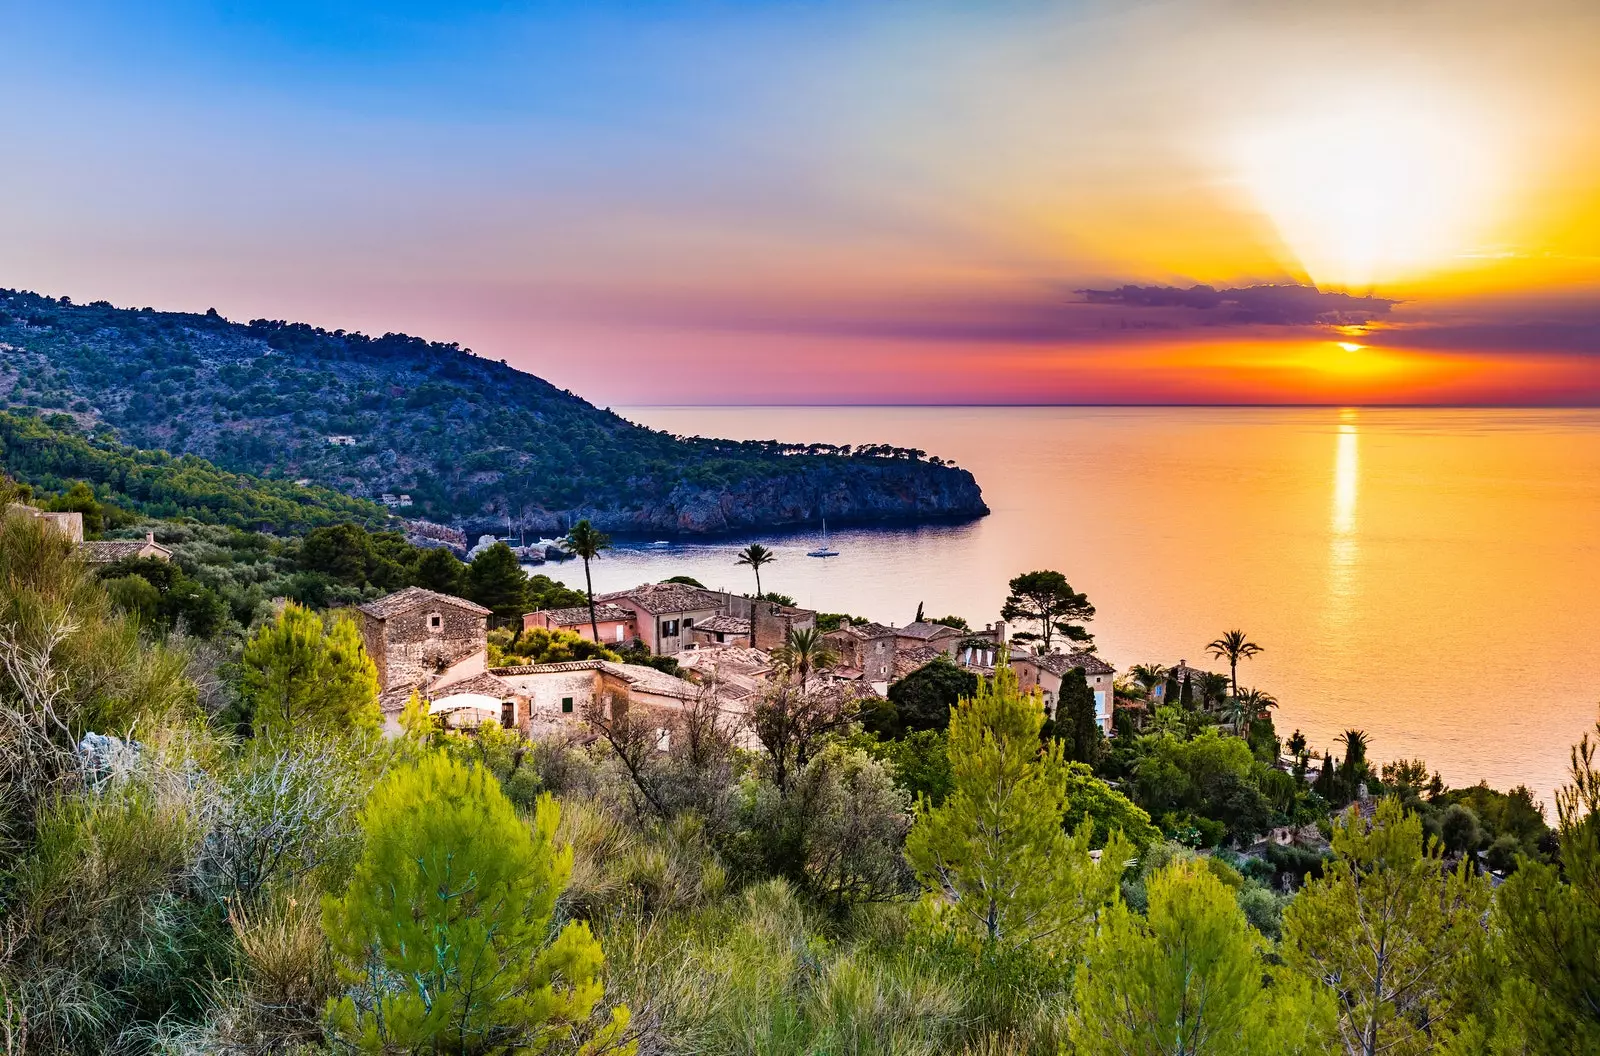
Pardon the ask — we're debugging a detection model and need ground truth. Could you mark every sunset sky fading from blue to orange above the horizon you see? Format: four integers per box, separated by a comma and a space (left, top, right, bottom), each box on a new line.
0, 0, 1600, 405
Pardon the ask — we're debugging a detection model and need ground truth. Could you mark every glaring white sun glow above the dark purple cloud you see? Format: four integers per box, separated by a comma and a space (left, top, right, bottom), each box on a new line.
1234, 90, 1502, 288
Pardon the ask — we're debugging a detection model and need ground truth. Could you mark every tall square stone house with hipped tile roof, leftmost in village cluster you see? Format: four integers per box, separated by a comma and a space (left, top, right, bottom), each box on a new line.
355, 587, 490, 704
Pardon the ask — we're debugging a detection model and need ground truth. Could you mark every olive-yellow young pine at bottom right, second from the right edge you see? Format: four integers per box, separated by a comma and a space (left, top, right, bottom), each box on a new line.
1283, 800, 1490, 1056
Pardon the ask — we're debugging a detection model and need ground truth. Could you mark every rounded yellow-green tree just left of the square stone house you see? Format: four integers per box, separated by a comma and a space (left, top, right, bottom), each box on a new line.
240, 602, 382, 736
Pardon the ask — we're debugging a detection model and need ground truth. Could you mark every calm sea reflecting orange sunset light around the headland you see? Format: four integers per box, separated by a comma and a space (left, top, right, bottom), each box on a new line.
544, 408, 1600, 797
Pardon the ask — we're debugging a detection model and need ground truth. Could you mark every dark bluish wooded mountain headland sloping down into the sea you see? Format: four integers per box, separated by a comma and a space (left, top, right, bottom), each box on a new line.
0, 290, 989, 534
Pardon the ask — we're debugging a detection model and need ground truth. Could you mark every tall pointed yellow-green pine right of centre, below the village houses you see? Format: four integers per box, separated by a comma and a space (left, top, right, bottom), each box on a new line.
906, 659, 1131, 963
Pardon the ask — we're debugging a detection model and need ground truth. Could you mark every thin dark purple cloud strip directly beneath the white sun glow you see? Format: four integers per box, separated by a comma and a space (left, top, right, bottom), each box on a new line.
1078, 285, 1398, 326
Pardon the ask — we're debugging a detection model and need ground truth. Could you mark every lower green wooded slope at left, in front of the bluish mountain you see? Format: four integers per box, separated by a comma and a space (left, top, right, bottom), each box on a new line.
0, 411, 389, 533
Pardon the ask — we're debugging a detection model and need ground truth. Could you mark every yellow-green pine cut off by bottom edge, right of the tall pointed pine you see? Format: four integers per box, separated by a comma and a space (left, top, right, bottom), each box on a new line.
1069, 861, 1334, 1056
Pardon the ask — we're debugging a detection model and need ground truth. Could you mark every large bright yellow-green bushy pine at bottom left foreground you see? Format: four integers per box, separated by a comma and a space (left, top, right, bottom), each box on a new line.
323, 754, 632, 1053
